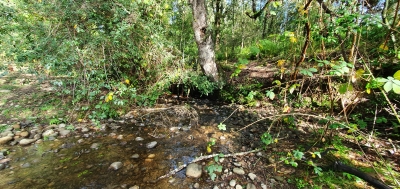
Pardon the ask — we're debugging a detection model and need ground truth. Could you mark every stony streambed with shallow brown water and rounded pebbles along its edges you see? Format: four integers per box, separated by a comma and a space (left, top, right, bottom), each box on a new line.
0, 101, 294, 189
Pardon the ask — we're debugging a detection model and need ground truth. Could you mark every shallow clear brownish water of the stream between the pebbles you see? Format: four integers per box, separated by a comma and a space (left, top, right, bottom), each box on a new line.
0, 102, 238, 189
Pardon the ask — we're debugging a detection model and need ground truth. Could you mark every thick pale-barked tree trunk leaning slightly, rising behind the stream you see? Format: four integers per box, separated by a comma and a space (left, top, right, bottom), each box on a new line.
189, 0, 218, 81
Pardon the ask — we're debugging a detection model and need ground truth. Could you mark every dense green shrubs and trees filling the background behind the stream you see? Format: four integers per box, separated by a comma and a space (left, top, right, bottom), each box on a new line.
0, 0, 400, 188
